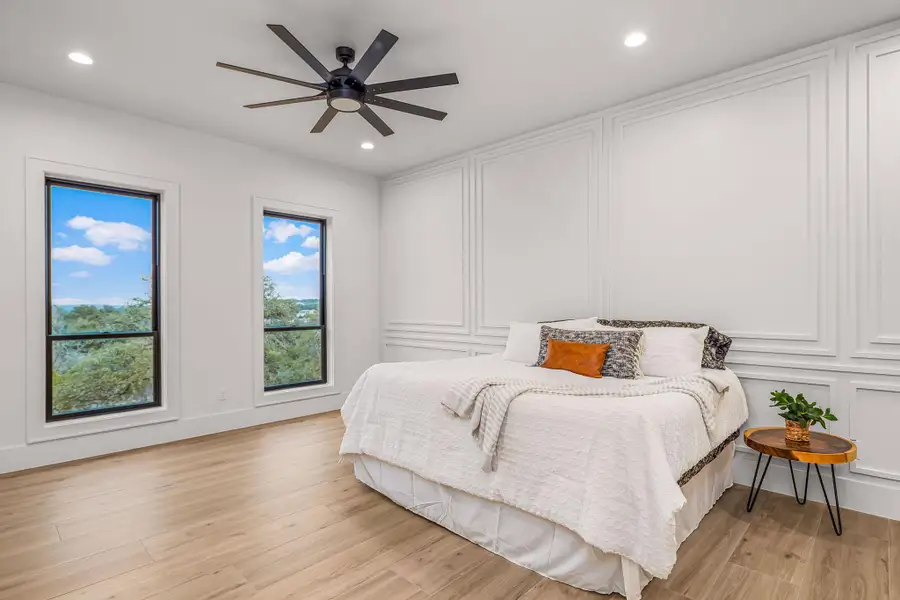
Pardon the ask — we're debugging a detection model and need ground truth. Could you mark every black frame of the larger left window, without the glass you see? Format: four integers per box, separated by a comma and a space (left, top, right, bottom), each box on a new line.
44, 177, 163, 423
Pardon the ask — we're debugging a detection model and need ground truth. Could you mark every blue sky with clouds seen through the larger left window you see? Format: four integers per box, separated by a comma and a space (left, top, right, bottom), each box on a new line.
50, 186, 153, 306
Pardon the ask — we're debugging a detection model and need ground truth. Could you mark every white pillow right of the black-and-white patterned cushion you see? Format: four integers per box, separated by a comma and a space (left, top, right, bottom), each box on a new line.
597, 324, 709, 377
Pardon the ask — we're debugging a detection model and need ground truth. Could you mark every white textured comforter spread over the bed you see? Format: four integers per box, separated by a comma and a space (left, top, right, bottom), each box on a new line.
341, 355, 747, 578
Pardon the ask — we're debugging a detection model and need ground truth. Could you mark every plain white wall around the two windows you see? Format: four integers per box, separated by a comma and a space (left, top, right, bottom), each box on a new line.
0, 85, 379, 472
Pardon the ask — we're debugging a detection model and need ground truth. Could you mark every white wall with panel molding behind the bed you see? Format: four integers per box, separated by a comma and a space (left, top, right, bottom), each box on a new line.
382, 23, 900, 518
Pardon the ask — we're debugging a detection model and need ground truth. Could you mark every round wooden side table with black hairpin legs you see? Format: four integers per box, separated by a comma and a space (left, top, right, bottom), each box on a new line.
744, 427, 856, 535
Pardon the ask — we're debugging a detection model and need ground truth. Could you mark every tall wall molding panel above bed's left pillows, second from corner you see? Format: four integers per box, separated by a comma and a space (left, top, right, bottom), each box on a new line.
472, 128, 599, 337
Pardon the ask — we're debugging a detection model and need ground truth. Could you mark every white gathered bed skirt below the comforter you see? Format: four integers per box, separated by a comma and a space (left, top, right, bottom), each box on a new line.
353, 442, 734, 600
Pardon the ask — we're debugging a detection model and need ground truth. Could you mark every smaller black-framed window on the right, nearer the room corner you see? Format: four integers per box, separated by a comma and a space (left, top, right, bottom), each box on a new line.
263, 212, 328, 391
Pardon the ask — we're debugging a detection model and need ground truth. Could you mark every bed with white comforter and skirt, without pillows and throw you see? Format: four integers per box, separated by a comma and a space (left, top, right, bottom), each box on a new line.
341, 355, 747, 600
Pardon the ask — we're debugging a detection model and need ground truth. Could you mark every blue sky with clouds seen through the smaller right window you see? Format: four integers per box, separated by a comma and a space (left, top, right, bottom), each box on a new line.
263, 216, 322, 300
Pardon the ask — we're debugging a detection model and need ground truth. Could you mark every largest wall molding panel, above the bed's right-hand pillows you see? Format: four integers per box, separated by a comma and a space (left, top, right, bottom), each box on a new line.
606, 53, 837, 356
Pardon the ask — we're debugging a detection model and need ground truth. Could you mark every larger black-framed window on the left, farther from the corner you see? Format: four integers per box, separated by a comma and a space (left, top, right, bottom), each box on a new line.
45, 179, 161, 421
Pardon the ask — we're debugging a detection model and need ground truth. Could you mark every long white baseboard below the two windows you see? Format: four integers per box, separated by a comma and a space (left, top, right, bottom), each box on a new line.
0, 394, 346, 473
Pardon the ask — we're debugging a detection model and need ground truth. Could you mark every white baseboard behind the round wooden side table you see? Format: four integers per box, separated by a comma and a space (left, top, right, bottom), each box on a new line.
733, 451, 900, 520
